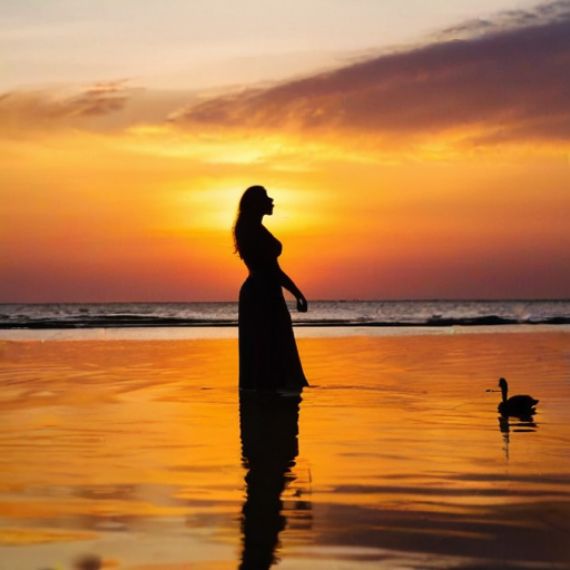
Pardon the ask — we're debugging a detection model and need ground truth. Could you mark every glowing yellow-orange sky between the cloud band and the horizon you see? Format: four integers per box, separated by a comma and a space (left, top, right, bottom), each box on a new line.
0, 116, 570, 301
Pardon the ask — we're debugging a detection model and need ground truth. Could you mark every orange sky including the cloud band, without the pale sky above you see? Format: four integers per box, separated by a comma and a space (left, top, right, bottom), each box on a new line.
0, 3, 570, 302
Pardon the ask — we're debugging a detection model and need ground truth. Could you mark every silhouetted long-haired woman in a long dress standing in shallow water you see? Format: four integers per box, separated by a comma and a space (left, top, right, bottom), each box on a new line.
234, 186, 308, 394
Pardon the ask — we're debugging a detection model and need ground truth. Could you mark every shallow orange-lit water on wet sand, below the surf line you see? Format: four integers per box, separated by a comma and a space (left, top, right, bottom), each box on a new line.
0, 327, 570, 570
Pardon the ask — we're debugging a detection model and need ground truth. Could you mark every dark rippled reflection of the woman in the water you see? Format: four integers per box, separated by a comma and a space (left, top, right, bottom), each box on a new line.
239, 392, 311, 570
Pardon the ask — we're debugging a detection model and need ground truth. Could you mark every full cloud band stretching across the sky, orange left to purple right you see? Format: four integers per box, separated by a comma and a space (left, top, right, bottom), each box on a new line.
5, 0, 570, 148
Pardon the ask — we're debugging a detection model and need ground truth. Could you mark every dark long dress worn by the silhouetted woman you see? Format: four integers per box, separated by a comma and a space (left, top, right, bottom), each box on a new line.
239, 226, 309, 391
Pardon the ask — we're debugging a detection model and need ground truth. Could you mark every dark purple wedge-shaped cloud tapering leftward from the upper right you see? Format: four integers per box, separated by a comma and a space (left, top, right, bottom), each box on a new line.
171, 1, 570, 144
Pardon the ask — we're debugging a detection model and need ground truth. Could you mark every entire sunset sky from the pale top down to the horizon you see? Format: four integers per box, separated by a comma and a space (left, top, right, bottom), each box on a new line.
0, 0, 570, 302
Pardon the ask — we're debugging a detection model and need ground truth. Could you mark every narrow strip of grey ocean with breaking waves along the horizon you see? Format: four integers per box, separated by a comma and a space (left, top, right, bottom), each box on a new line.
0, 300, 570, 329
